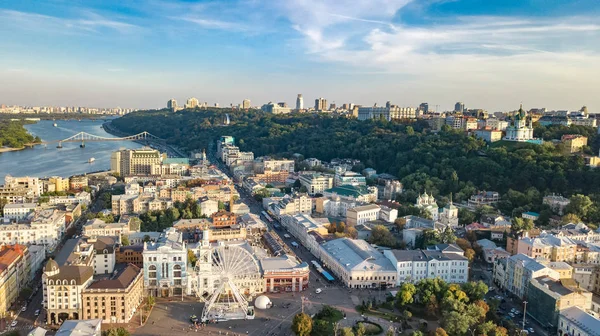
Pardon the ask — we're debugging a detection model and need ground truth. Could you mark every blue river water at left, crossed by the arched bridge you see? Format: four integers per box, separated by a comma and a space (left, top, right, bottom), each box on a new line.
0, 119, 142, 181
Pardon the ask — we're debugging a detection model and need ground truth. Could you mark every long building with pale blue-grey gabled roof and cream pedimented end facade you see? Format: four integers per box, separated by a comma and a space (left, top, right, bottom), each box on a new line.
320, 238, 397, 288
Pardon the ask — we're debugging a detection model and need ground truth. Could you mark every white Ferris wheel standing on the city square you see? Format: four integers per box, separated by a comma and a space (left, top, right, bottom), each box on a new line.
202, 246, 260, 322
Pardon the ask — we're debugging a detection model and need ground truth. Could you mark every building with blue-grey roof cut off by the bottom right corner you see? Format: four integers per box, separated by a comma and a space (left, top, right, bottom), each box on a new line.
558, 307, 600, 336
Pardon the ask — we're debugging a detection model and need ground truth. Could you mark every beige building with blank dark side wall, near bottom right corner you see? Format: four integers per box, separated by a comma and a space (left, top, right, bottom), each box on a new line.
527, 276, 592, 329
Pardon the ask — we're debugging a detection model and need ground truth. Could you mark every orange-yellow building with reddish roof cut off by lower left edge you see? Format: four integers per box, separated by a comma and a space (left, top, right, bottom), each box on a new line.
0, 245, 29, 317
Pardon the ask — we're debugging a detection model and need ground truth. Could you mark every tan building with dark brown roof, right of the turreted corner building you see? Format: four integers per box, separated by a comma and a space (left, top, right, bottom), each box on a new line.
81, 264, 144, 323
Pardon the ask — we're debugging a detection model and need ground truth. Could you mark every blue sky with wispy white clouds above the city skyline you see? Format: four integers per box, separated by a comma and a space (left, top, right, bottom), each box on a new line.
0, 0, 600, 112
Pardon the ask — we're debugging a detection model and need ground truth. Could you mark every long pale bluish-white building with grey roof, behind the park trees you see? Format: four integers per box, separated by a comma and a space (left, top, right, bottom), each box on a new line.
383, 250, 469, 286
